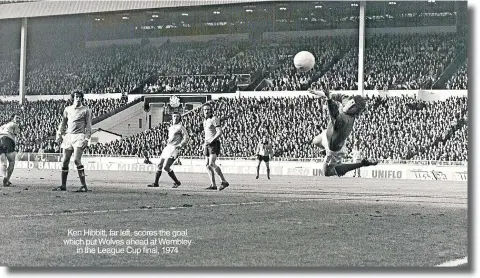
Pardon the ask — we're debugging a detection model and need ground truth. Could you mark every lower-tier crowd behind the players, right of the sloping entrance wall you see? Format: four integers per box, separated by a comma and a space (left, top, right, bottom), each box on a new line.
87, 96, 467, 160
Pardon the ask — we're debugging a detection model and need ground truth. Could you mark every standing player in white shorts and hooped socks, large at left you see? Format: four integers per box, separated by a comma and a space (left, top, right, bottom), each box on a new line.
53, 90, 92, 192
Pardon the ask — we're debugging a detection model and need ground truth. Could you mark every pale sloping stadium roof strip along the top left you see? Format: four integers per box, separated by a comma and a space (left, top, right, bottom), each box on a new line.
0, 0, 272, 19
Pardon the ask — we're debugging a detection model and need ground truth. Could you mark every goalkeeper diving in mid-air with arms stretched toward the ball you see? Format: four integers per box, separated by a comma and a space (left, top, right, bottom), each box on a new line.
310, 84, 378, 177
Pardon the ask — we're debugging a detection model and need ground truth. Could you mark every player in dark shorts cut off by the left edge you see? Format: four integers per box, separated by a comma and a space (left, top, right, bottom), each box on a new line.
0, 114, 20, 186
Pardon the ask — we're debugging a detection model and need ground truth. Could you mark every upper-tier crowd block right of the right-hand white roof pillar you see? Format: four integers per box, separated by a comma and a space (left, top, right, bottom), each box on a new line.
365, 34, 460, 90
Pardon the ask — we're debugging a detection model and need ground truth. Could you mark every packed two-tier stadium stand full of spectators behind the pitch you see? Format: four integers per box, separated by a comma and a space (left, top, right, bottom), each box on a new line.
0, 1, 468, 160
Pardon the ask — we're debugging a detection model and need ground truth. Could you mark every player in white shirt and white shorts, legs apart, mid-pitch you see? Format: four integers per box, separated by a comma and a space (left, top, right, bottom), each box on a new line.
148, 113, 189, 188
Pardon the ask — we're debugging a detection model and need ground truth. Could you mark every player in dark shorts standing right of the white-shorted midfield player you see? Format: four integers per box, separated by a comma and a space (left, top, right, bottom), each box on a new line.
203, 104, 230, 190
